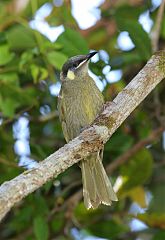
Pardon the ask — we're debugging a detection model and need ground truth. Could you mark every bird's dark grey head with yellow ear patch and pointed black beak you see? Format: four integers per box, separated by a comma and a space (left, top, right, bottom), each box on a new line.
60, 52, 97, 81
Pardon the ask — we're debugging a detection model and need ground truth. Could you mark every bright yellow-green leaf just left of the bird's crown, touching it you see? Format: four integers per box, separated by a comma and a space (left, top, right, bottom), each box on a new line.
47, 51, 67, 70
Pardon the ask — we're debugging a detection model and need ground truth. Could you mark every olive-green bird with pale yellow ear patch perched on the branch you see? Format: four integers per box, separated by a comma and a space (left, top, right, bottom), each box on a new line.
58, 52, 117, 208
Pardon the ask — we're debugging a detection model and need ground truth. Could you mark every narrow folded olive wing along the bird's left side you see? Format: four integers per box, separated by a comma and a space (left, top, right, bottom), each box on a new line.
57, 89, 69, 142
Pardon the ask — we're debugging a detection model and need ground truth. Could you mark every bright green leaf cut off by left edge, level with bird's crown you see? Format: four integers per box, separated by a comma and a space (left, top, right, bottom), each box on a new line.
0, 44, 14, 65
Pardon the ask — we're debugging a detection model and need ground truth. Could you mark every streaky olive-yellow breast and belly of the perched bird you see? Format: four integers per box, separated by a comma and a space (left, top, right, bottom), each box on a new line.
62, 81, 103, 138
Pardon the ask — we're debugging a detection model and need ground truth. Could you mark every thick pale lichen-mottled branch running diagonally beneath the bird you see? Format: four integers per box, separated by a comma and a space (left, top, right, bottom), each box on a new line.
0, 51, 165, 219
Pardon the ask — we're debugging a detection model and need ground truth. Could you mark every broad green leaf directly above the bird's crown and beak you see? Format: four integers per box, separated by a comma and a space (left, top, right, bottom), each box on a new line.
57, 28, 89, 56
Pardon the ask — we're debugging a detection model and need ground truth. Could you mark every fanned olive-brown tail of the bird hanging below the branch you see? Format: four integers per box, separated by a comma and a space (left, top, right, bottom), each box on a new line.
81, 153, 118, 209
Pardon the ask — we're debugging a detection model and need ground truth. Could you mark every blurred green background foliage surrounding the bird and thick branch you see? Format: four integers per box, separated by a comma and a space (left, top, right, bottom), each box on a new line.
0, 0, 165, 240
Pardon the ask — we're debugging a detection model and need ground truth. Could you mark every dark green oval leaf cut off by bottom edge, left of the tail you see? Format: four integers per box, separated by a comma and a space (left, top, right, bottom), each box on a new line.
33, 216, 49, 240
